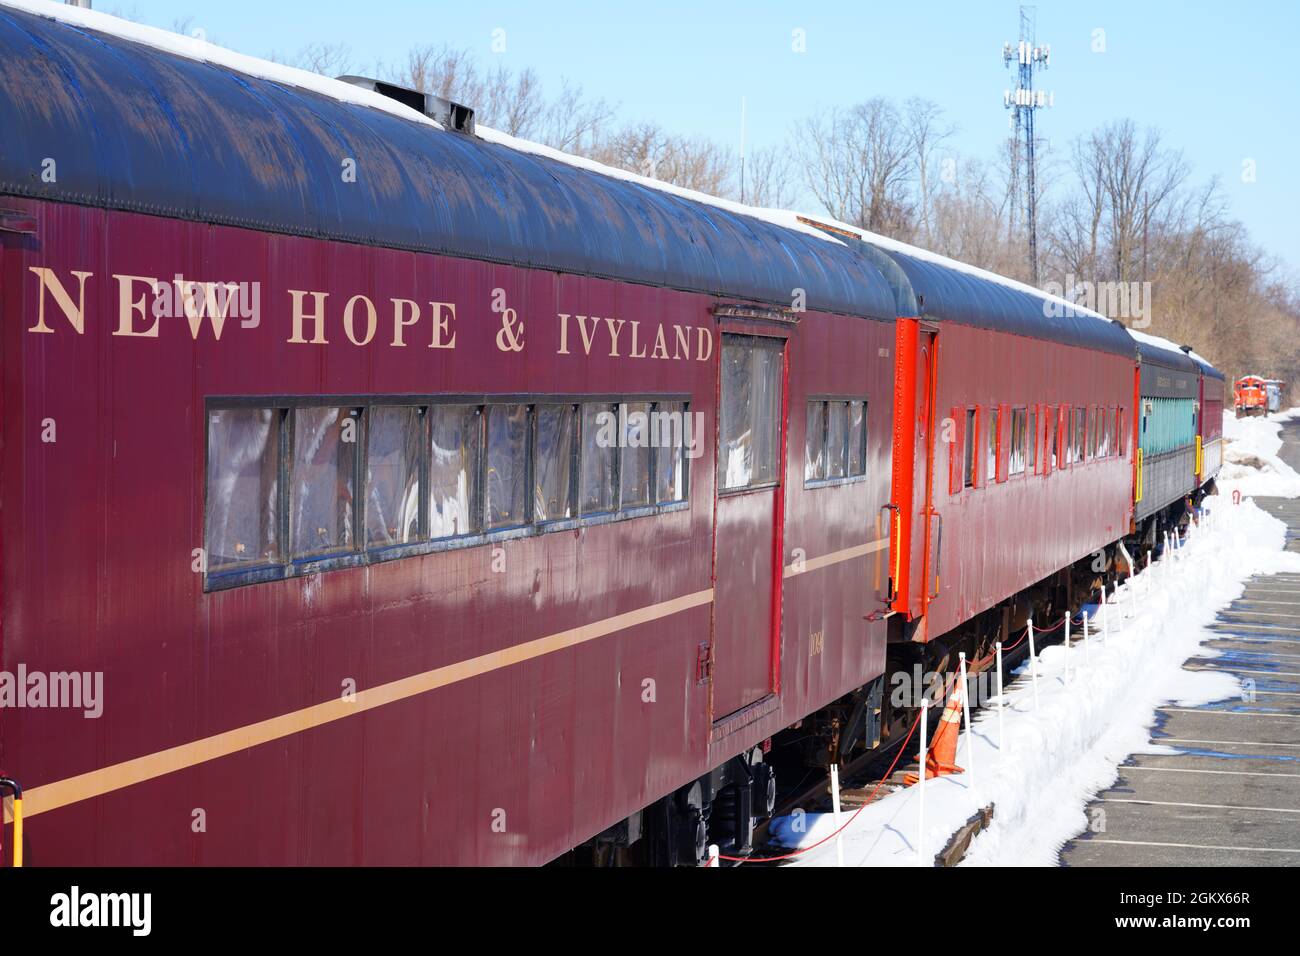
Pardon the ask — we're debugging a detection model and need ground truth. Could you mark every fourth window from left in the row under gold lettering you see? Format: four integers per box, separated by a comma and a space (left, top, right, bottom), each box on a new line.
429, 405, 482, 538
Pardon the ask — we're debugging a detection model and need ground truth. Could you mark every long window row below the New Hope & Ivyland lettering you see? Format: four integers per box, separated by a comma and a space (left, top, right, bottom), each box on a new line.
205, 401, 689, 575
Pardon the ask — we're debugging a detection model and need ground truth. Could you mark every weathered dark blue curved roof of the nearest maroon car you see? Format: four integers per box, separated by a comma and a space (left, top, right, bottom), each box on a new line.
0, 5, 894, 319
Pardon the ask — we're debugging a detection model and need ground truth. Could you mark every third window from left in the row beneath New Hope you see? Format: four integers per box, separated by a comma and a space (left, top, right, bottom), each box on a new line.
365, 405, 424, 548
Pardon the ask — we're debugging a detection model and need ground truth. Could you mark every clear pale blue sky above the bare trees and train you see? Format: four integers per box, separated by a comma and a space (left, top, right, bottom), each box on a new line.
104, 0, 1300, 276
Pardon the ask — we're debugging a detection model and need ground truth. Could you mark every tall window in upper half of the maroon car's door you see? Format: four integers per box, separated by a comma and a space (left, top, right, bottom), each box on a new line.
718, 334, 784, 490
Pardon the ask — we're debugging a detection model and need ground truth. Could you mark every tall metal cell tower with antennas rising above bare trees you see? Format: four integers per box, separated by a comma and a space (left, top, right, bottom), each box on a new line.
1002, 7, 1056, 285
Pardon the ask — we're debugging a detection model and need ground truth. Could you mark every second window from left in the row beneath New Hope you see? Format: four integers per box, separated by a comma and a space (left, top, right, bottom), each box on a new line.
289, 406, 361, 558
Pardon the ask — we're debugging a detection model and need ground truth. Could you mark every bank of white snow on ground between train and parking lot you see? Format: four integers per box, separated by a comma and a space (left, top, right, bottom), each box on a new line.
770, 408, 1300, 866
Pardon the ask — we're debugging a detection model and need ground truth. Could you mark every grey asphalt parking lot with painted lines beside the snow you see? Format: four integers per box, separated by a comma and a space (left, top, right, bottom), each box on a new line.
1061, 423, 1300, 866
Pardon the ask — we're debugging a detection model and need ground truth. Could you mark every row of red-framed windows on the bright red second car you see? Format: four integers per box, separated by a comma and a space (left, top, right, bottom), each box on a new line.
949, 405, 1126, 494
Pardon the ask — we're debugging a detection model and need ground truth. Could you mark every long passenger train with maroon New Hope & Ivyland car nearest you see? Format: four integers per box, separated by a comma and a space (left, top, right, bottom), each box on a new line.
0, 0, 1223, 866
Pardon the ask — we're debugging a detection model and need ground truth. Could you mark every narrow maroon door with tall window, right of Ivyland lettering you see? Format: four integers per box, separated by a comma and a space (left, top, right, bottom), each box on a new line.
712, 333, 787, 721
